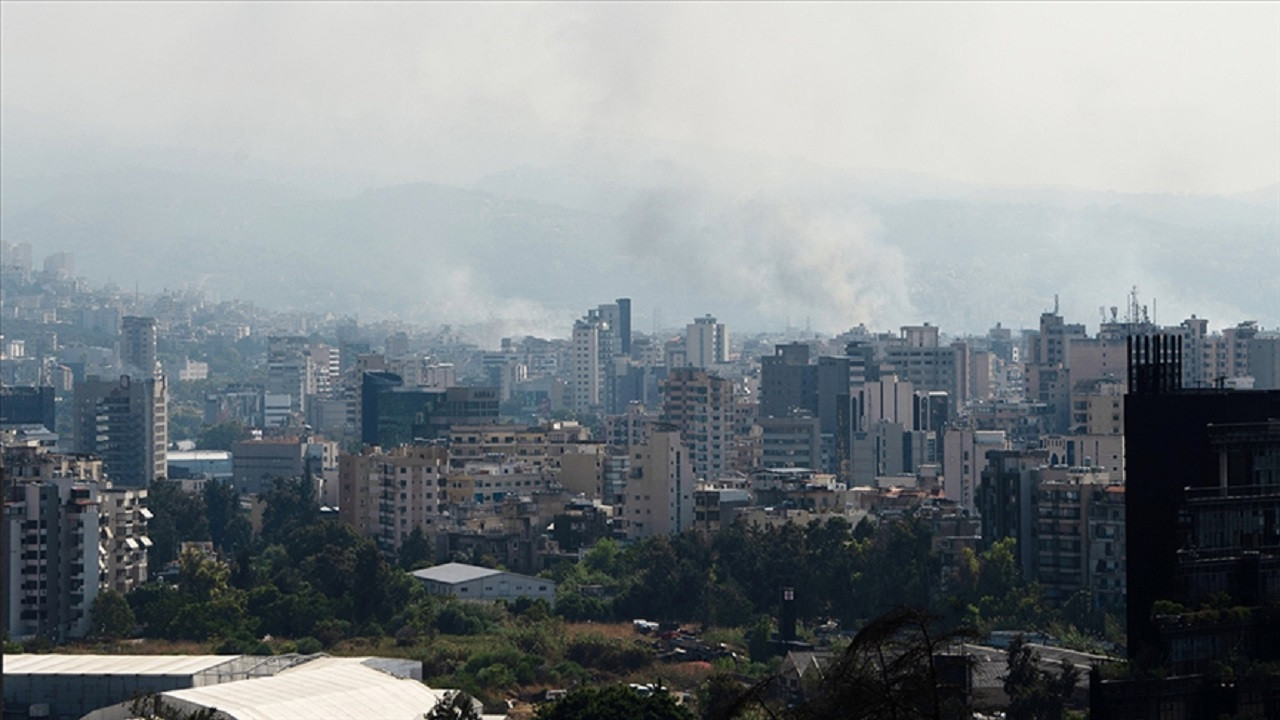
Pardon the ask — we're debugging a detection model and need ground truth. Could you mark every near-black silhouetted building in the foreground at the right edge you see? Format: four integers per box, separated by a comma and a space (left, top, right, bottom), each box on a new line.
1124, 336, 1280, 662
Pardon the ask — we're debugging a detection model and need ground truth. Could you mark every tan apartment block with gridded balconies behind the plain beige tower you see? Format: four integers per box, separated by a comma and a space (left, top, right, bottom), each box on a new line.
650, 368, 733, 480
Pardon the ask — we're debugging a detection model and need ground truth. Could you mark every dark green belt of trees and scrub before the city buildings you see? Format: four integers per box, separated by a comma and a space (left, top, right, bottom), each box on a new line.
117, 479, 1121, 717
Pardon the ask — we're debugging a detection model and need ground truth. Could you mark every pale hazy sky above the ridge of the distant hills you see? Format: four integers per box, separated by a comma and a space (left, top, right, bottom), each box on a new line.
0, 0, 1280, 193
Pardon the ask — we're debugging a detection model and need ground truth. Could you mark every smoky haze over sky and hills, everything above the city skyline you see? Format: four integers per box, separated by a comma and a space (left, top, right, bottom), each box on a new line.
0, 3, 1280, 341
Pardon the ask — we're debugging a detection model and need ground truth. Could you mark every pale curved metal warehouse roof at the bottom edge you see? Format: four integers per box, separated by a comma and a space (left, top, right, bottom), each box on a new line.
164, 657, 443, 720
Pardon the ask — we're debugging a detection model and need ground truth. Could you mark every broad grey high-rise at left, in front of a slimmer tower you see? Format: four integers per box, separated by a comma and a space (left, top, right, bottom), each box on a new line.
74, 375, 169, 487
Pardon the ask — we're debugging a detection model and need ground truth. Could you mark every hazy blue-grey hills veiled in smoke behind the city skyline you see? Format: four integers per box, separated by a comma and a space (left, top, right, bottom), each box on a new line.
0, 162, 1280, 334
